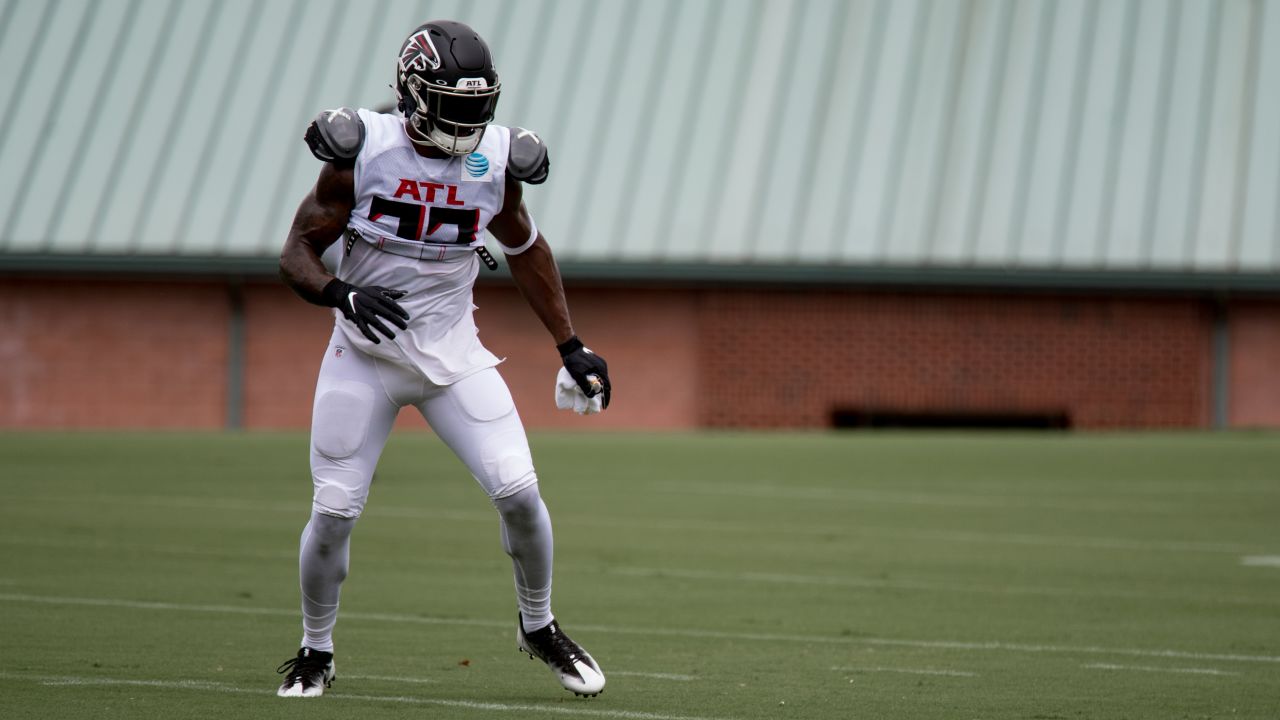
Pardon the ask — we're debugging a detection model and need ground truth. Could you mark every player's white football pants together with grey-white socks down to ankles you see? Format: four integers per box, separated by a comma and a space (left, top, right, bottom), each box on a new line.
298, 331, 553, 652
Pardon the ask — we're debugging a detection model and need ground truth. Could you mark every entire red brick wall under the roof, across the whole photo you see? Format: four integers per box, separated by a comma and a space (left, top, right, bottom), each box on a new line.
0, 277, 1280, 429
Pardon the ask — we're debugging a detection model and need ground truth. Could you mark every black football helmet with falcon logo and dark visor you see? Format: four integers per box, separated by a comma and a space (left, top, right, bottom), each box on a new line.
396, 20, 502, 155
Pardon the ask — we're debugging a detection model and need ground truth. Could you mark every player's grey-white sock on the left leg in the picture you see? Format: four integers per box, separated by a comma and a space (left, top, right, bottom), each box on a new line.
298, 511, 356, 652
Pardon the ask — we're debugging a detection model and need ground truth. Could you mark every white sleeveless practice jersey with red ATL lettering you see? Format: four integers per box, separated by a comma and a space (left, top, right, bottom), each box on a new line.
334, 109, 511, 386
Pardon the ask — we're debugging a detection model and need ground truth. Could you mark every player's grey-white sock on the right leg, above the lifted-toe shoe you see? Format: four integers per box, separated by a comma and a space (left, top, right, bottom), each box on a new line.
493, 486, 554, 633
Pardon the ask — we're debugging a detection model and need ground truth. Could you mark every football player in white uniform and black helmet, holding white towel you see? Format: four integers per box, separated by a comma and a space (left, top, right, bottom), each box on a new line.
278, 20, 612, 697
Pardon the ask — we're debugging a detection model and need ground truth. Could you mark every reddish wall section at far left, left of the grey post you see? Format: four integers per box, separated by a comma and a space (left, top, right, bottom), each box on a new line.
0, 278, 229, 428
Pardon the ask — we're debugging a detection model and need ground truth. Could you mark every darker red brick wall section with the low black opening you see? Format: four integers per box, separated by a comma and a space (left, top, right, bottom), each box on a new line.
699, 291, 1211, 428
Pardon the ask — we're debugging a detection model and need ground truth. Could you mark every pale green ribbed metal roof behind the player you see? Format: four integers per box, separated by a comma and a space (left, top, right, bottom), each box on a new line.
0, 0, 1280, 286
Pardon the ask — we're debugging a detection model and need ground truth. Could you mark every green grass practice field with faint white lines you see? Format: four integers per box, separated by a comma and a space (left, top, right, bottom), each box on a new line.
0, 433, 1280, 720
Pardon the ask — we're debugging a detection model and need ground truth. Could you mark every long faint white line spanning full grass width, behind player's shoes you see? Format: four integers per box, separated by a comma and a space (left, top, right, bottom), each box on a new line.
0, 593, 1280, 664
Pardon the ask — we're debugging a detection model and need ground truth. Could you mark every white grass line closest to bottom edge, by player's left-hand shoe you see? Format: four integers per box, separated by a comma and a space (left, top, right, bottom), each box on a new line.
0, 671, 731, 720
